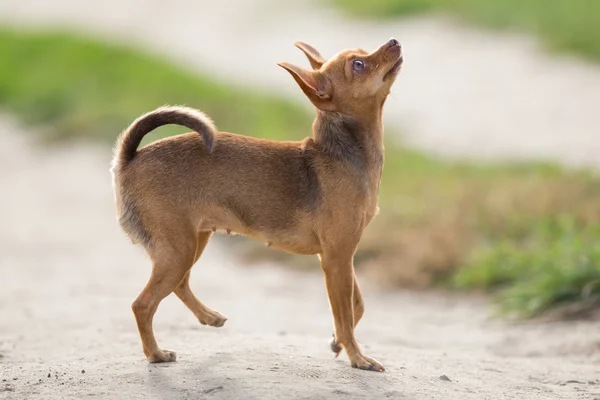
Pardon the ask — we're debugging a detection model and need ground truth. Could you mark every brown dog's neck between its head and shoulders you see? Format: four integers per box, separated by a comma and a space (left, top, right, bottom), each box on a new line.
313, 110, 383, 171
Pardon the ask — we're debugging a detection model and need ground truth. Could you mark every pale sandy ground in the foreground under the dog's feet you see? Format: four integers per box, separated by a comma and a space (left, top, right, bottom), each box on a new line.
0, 118, 600, 399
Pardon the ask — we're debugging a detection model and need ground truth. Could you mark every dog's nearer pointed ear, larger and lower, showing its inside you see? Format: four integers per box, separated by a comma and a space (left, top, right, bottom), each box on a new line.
277, 62, 334, 111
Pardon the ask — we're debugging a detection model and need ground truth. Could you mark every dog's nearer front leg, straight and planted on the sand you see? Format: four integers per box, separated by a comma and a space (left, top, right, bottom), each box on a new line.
321, 249, 384, 371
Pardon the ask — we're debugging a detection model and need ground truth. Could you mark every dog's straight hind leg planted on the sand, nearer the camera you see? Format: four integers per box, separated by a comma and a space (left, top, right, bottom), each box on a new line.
131, 234, 195, 363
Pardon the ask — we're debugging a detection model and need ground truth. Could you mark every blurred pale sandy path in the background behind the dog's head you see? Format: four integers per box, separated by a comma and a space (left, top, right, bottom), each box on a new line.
0, 0, 600, 166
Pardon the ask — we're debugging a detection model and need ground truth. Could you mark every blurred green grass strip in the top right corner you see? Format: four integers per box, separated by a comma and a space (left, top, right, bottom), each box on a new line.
332, 0, 600, 60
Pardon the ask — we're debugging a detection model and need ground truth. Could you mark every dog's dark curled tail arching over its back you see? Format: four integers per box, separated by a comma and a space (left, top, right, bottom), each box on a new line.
112, 106, 217, 173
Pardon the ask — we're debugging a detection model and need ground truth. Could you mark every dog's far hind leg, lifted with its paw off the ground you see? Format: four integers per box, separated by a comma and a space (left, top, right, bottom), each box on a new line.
175, 232, 227, 327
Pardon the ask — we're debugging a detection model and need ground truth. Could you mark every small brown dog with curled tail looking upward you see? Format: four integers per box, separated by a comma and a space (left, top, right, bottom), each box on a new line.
112, 39, 403, 371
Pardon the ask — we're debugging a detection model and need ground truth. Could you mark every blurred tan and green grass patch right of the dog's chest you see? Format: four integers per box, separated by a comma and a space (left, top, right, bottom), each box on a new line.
362, 149, 600, 317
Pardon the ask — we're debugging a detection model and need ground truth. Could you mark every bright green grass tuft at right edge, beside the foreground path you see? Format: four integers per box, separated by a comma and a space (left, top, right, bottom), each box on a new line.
451, 216, 600, 317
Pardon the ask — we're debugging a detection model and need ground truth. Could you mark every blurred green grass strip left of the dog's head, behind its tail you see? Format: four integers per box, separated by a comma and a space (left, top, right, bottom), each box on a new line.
0, 30, 310, 145
